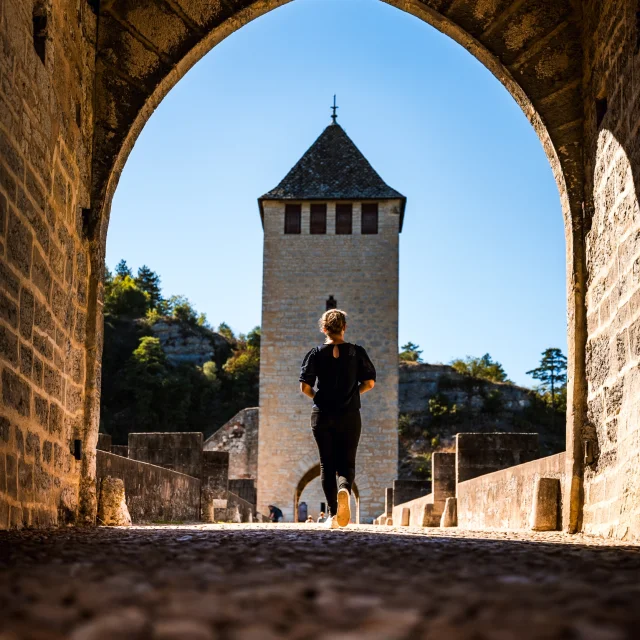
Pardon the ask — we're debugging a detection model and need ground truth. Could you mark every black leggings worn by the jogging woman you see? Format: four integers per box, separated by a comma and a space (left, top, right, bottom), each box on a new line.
311, 411, 362, 516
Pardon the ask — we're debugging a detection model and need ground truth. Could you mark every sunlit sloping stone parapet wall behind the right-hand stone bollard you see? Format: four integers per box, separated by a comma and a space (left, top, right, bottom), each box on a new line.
456, 453, 566, 531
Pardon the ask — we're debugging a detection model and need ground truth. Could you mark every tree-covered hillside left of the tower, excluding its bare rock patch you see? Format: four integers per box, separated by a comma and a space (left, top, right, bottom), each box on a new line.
100, 260, 260, 444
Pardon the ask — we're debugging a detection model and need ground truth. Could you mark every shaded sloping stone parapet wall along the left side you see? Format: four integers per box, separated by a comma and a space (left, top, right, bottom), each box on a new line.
96, 451, 201, 524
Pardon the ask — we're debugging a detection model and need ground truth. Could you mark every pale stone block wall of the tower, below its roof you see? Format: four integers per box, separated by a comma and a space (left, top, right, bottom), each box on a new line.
258, 201, 400, 522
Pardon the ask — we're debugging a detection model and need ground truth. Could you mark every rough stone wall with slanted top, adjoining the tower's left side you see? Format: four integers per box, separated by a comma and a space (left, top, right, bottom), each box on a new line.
204, 407, 259, 479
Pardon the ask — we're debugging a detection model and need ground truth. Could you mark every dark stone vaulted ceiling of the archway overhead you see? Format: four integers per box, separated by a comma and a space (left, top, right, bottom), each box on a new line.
91, 0, 583, 230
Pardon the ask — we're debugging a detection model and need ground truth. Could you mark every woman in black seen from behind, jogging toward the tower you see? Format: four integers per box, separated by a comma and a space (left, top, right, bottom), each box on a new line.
300, 309, 376, 529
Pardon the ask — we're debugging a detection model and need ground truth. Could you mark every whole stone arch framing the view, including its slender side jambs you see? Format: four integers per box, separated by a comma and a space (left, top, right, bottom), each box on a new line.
82, 0, 586, 530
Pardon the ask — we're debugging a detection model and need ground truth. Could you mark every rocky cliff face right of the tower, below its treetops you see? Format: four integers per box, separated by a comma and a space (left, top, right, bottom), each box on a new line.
398, 362, 565, 479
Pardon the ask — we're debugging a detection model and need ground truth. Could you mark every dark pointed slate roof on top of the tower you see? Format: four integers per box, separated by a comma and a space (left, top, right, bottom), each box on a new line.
258, 124, 406, 229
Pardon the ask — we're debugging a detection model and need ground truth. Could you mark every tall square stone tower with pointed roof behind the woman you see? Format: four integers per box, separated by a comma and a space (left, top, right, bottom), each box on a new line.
258, 116, 406, 522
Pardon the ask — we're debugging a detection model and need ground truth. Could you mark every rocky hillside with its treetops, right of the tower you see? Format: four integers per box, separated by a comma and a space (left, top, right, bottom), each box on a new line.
398, 343, 566, 479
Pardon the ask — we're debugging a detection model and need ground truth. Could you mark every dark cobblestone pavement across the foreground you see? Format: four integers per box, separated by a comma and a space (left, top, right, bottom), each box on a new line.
0, 525, 640, 640
